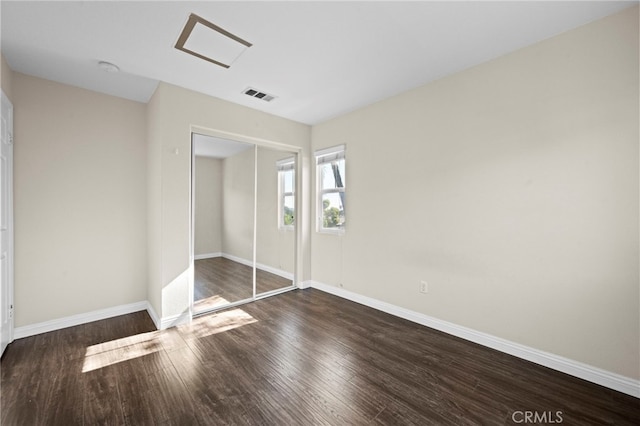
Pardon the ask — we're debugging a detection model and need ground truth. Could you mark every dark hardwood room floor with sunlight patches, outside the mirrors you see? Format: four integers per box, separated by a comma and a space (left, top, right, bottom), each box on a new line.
0, 289, 640, 426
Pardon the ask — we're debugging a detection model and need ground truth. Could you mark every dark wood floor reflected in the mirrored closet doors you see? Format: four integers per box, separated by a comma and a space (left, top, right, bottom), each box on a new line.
193, 257, 292, 311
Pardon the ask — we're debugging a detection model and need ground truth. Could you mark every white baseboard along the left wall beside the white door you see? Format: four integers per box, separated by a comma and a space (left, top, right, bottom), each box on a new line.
13, 300, 149, 340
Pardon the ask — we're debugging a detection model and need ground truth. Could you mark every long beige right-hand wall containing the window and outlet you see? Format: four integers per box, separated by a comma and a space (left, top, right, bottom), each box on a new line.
312, 7, 640, 379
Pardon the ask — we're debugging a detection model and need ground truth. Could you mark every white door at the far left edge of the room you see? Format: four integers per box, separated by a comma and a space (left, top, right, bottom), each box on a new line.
0, 92, 13, 354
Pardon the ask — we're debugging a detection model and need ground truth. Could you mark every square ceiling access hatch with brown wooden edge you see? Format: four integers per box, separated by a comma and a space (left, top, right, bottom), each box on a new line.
174, 13, 252, 68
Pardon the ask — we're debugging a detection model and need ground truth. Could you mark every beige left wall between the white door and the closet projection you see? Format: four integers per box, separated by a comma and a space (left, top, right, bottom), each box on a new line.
12, 73, 147, 327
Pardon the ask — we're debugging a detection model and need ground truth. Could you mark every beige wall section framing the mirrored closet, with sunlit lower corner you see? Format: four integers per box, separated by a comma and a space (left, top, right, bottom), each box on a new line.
148, 83, 310, 319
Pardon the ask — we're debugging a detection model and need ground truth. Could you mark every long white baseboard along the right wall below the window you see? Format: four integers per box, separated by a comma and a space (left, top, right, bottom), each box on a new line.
303, 281, 640, 398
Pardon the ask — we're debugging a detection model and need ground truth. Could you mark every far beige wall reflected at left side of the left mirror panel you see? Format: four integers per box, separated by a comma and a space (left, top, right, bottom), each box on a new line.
193, 157, 222, 256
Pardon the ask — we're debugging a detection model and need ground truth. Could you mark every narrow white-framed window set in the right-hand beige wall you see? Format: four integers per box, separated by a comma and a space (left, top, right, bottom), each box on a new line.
316, 145, 346, 234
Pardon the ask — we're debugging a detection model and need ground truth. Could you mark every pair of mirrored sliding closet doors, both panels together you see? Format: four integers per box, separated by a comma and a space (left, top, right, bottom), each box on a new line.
192, 132, 298, 315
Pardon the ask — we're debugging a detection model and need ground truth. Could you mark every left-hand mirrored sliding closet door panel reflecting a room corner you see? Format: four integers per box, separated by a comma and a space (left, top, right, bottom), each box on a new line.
192, 133, 255, 312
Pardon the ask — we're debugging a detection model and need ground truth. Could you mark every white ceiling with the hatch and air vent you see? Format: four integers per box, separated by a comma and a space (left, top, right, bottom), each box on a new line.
0, 0, 638, 124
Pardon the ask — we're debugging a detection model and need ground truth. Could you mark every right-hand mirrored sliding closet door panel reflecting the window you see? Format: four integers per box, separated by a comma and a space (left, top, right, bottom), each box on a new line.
256, 146, 296, 294
